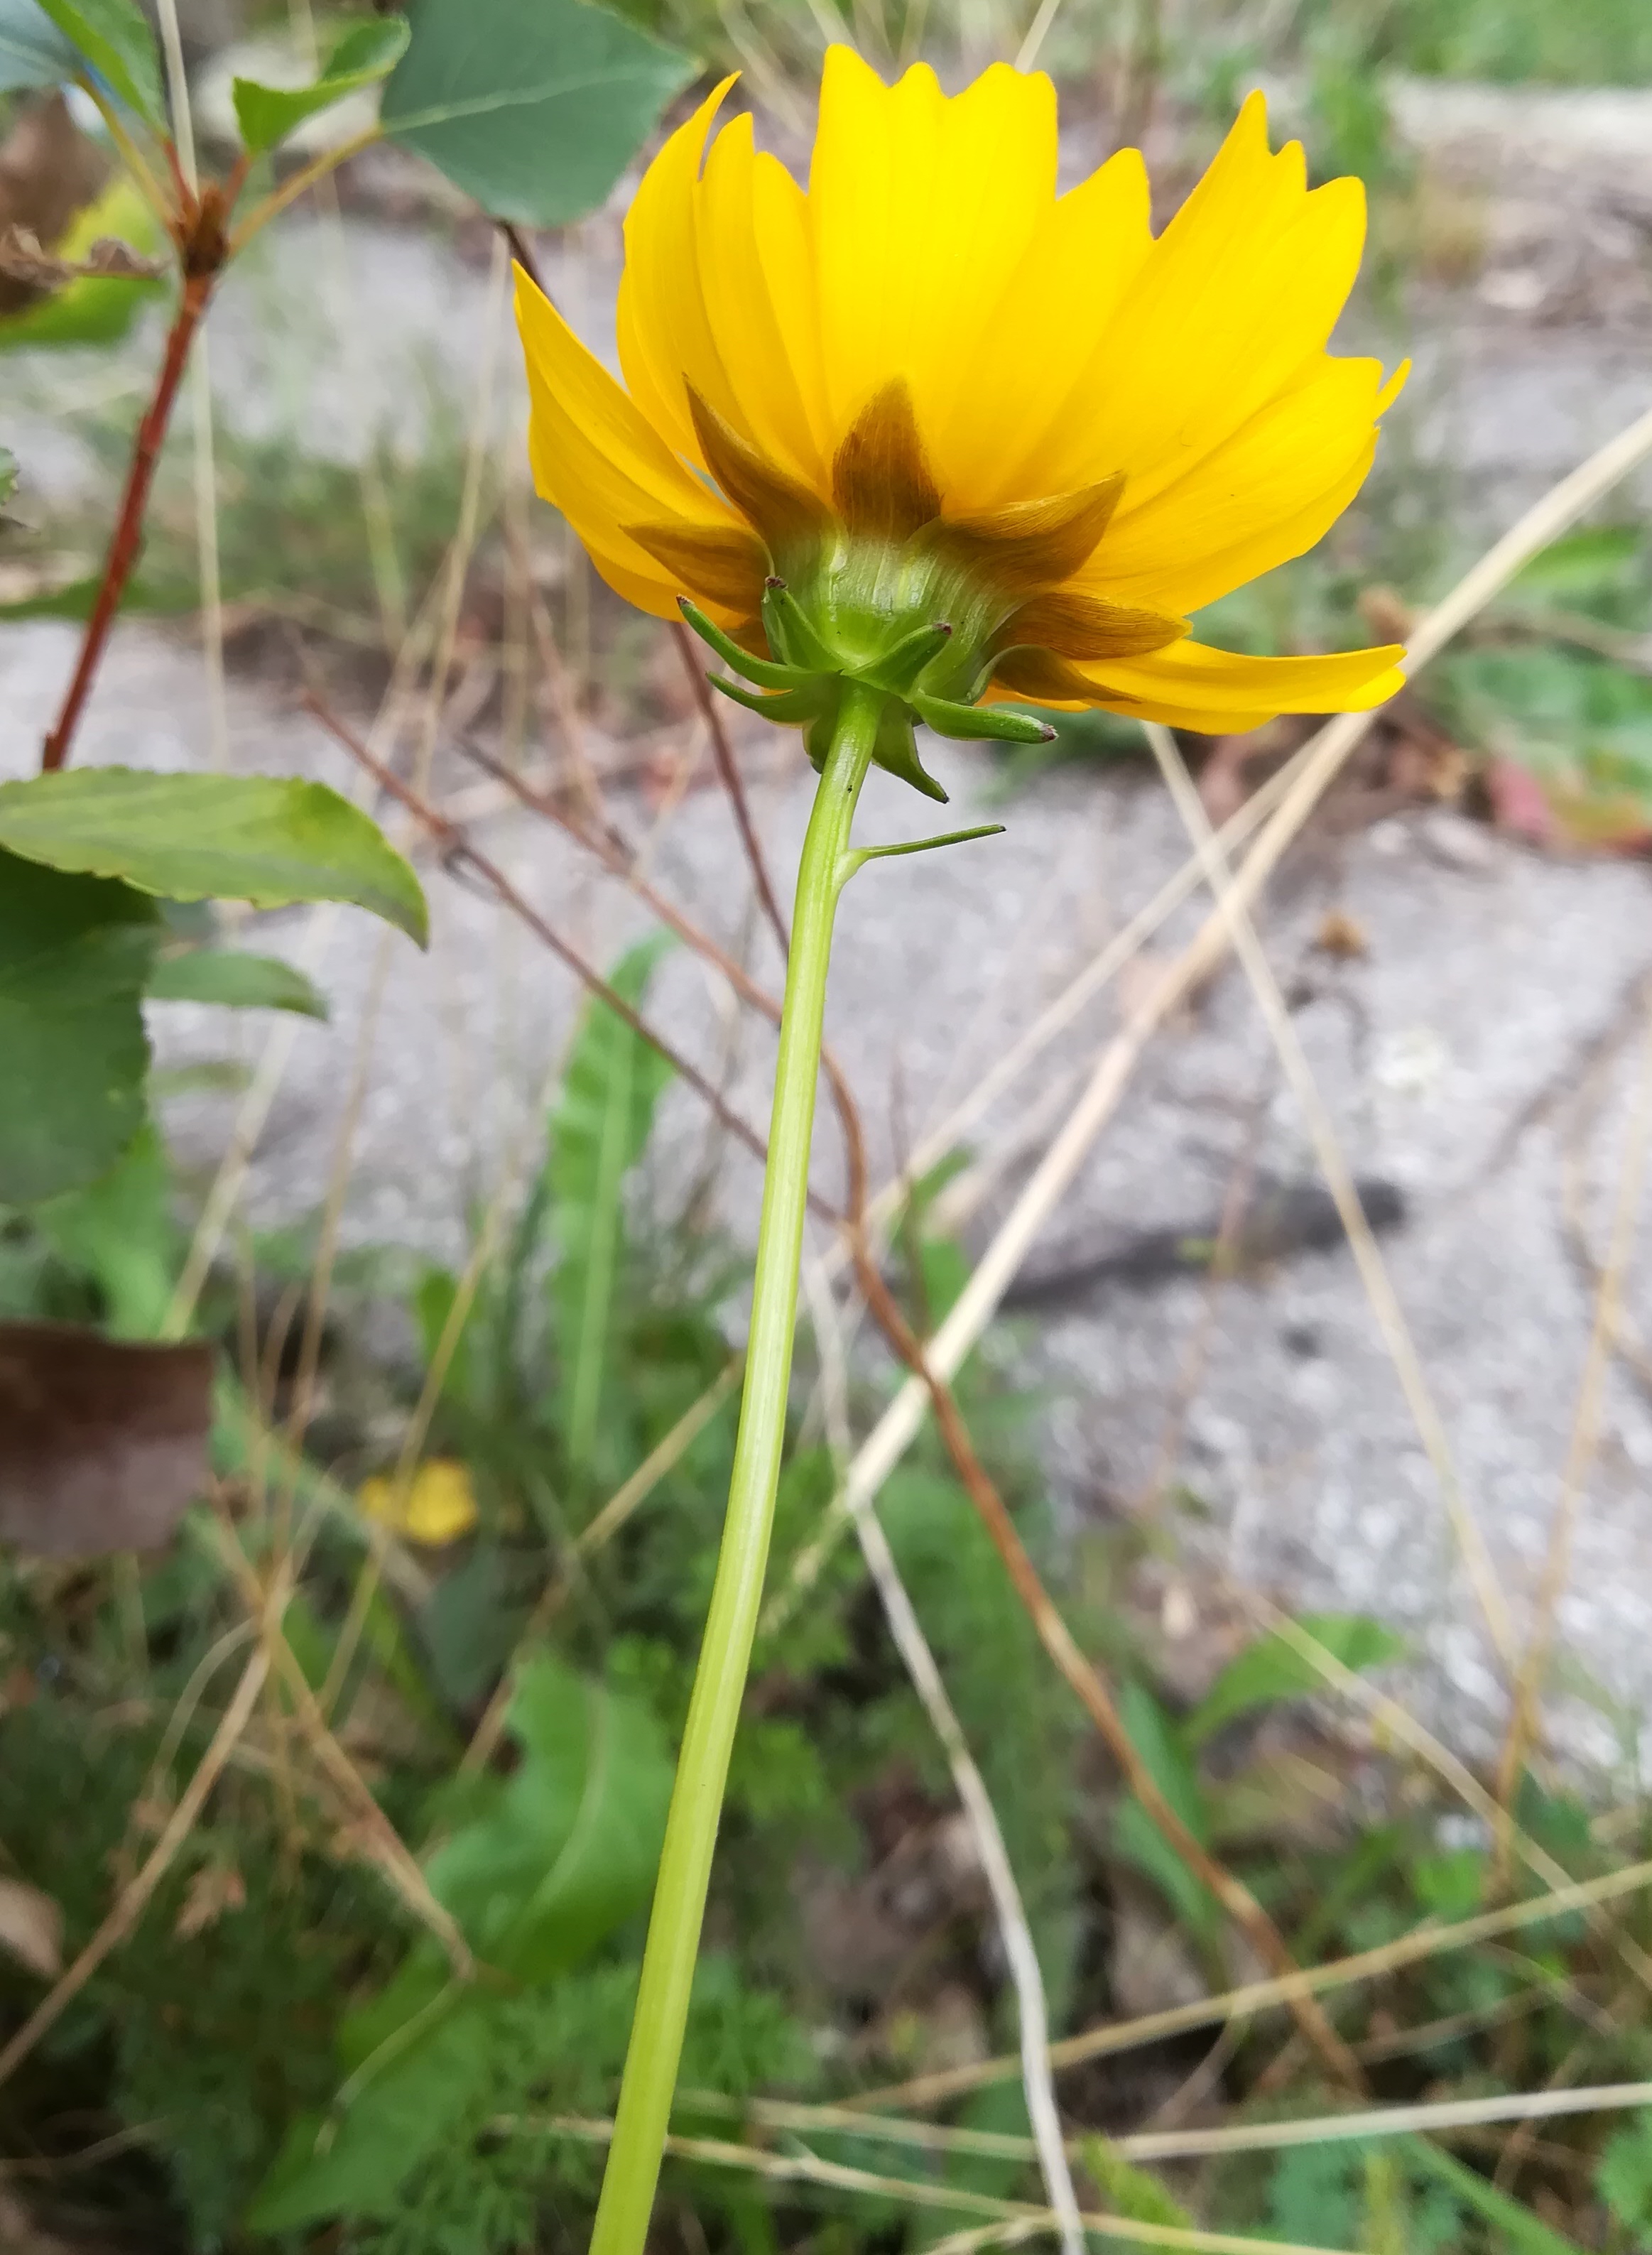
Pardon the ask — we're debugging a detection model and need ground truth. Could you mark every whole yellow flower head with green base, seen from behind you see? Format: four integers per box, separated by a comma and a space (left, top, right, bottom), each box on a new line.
516, 48, 1404, 796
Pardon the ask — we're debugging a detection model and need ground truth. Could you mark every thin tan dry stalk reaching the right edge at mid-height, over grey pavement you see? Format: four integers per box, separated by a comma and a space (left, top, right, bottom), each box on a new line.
1496, 1006, 1652, 1831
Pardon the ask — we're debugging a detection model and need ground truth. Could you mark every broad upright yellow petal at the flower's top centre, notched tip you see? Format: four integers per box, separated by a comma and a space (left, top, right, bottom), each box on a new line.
809, 48, 1057, 462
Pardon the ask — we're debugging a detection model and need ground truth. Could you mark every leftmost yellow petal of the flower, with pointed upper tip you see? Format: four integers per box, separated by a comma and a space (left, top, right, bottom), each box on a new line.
516, 271, 734, 618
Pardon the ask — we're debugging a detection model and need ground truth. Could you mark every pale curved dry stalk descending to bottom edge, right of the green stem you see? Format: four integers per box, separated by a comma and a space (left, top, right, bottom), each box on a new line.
805, 1261, 1084, 2255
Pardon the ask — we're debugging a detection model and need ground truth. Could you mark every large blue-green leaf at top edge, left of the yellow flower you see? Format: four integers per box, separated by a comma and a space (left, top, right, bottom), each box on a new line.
379, 0, 694, 228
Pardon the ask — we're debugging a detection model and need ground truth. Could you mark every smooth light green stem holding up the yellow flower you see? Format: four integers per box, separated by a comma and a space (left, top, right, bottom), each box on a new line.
590, 683, 884, 2255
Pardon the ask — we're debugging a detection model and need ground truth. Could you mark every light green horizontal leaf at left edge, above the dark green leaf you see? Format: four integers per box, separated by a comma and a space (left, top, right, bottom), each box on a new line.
0, 767, 428, 947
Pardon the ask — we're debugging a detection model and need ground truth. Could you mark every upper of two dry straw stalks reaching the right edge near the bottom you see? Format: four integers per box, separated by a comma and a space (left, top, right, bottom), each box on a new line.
859, 1863, 1652, 2106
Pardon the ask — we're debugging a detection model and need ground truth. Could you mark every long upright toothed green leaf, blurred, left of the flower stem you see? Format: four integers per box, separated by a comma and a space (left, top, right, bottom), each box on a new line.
545, 938, 669, 1470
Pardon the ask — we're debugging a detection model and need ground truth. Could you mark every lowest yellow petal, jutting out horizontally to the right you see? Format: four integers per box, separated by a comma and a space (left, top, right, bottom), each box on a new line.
1036, 643, 1404, 735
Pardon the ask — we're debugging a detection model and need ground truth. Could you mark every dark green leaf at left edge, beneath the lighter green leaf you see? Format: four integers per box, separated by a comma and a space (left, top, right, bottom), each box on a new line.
0, 852, 160, 1207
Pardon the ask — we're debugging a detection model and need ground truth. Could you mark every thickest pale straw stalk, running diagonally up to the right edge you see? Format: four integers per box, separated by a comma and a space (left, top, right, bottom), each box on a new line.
768, 392, 1652, 1626
